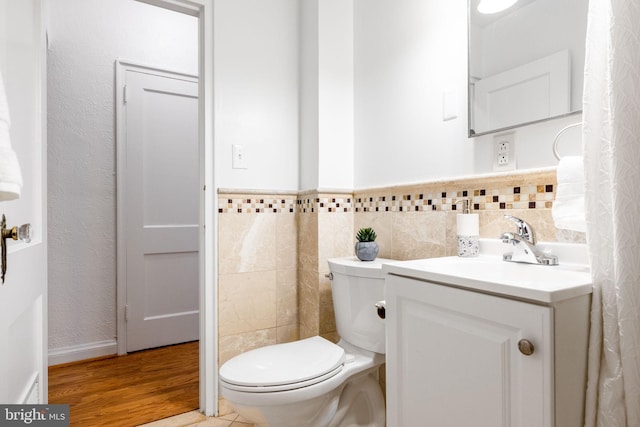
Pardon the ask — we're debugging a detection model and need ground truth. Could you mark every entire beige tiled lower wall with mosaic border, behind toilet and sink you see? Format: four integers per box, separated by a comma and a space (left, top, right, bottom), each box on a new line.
218, 169, 584, 412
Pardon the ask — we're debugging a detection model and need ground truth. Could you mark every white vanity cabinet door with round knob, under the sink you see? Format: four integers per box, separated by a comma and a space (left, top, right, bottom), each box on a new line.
385, 276, 553, 427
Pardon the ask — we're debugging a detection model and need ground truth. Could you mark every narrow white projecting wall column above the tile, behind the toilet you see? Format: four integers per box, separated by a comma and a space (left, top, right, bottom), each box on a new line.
299, 0, 354, 190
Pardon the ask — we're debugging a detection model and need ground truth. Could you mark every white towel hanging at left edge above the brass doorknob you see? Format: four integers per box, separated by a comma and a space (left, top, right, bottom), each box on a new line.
0, 71, 22, 201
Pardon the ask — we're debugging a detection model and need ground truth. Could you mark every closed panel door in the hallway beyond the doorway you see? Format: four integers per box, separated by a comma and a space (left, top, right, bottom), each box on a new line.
120, 70, 200, 351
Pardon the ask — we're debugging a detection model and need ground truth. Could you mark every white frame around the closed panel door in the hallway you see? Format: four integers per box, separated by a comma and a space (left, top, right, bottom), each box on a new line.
115, 58, 203, 356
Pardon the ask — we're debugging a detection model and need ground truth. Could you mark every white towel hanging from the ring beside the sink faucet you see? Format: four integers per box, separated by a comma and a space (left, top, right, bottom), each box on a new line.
551, 156, 587, 232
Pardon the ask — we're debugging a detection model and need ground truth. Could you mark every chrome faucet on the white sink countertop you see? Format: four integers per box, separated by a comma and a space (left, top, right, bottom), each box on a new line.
500, 215, 558, 265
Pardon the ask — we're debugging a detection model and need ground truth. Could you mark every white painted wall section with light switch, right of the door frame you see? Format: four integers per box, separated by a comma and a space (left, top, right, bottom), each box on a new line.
213, 0, 299, 190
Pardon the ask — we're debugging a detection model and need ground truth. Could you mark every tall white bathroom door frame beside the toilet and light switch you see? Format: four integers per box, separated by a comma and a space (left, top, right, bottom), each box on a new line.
124, 0, 218, 416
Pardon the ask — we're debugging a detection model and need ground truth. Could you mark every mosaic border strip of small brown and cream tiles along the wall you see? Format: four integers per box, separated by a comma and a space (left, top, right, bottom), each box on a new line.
218, 170, 556, 214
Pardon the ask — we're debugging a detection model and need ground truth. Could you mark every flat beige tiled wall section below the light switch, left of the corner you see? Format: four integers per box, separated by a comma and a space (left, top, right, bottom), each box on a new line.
218, 193, 299, 364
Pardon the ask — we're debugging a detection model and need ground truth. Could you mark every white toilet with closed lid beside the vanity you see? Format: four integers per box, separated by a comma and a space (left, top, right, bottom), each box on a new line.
220, 257, 390, 427
